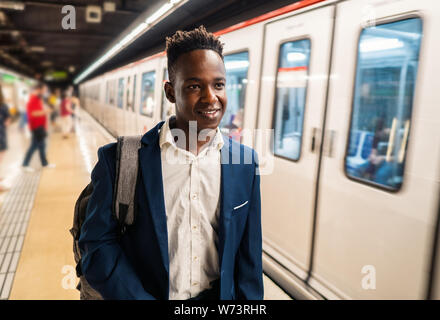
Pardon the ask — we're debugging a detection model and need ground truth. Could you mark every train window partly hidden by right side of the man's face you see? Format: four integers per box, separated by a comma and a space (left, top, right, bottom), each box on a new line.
220, 51, 249, 141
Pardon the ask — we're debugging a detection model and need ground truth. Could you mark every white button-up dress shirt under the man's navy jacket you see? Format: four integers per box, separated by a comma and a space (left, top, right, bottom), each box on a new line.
159, 118, 224, 300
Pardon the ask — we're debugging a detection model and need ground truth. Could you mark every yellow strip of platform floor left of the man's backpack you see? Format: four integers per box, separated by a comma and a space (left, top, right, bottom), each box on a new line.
9, 129, 90, 299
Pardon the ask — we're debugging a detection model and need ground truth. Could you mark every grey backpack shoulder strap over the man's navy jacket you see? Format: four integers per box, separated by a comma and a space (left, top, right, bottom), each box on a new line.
113, 136, 142, 234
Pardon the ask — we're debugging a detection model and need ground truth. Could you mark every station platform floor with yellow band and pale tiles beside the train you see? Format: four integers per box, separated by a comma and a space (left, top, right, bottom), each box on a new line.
0, 112, 290, 300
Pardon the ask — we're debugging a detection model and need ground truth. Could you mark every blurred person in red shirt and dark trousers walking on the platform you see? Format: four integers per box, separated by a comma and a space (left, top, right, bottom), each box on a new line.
23, 83, 55, 172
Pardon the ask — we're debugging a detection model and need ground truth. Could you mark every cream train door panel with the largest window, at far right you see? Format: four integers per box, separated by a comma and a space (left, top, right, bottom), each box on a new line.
310, 0, 440, 299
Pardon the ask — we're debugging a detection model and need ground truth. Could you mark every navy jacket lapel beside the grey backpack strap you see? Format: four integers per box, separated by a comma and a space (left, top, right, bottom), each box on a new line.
139, 122, 169, 272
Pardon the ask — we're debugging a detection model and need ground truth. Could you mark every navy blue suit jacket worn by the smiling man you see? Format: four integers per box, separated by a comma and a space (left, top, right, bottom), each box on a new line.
79, 122, 263, 300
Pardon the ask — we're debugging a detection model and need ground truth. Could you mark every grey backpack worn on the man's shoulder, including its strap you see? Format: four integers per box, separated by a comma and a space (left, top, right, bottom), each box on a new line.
70, 136, 141, 300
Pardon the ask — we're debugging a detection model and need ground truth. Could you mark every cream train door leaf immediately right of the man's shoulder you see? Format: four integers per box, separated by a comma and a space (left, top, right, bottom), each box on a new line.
256, 6, 333, 279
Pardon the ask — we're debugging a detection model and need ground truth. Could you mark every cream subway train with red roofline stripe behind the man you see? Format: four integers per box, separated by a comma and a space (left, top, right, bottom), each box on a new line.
79, 0, 440, 299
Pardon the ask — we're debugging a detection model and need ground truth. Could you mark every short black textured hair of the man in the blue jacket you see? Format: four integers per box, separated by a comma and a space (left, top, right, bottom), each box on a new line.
166, 25, 223, 83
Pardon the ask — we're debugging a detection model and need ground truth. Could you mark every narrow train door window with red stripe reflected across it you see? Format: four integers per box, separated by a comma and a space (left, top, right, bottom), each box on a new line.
273, 39, 310, 161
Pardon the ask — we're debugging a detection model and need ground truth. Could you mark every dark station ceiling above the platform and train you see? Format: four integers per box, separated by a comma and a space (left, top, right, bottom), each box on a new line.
0, 0, 297, 86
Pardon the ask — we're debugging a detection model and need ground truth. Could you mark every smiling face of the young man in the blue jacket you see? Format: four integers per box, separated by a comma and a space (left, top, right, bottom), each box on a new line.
165, 50, 227, 132
